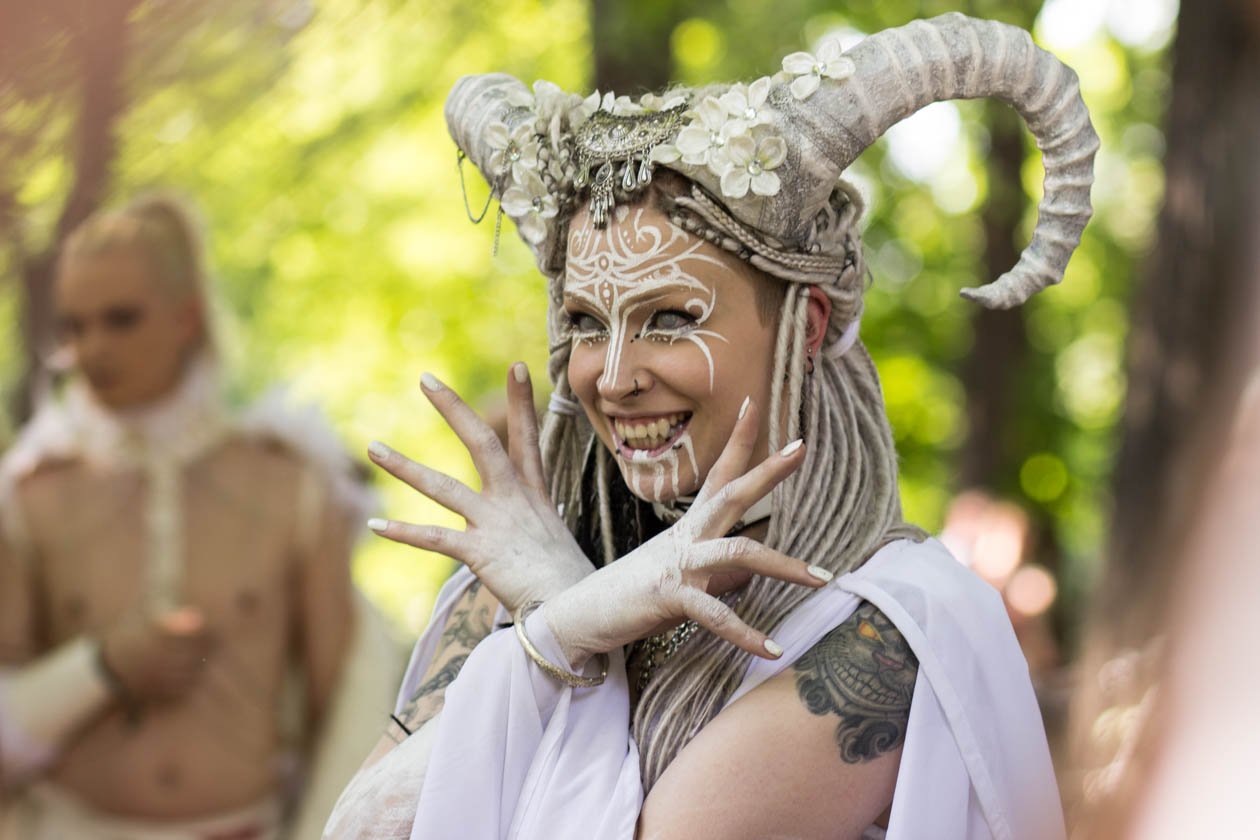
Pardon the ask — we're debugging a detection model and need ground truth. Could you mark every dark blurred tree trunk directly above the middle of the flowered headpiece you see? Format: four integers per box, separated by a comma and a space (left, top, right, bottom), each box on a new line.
591, 0, 682, 97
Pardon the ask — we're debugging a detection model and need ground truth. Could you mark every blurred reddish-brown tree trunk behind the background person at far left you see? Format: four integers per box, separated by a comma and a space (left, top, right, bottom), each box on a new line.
8, 0, 140, 422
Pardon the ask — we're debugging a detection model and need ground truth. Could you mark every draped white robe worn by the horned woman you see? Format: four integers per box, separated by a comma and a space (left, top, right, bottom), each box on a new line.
326, 540, 1065, 840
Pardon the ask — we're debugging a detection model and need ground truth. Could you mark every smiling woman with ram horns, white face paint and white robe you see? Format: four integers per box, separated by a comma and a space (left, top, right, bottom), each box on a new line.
326, 14, 1097, 840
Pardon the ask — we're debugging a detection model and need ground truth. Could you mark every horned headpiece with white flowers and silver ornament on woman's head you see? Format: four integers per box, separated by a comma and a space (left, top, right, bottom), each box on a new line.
446, 13, 1099, 309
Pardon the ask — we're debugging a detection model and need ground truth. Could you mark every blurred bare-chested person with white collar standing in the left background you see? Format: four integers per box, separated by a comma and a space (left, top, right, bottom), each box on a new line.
0, 195, 393, 840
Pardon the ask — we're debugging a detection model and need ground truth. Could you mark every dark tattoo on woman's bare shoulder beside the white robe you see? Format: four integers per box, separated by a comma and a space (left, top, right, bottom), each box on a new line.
793, 602, 919, 764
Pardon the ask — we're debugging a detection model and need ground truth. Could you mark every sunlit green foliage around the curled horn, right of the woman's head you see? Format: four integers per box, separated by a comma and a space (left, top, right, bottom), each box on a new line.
650, 0, 1168, 637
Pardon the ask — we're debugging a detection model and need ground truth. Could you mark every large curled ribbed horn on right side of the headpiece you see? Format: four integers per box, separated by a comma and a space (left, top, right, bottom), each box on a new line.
766, 13, 1099, 309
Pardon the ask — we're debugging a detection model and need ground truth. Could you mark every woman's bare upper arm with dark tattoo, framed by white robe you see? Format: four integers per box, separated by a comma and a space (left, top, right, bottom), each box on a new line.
639, 603, 919, 840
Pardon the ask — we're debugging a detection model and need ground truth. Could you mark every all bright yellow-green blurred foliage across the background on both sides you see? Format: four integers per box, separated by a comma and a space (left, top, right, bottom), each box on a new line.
0, 0, 1167, 630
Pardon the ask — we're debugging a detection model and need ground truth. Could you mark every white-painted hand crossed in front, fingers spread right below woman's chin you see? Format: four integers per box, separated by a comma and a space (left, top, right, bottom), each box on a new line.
541, 400, 832, 670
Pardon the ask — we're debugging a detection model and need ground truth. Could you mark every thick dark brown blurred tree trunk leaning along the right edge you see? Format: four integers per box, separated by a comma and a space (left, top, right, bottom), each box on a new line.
1065, 0, 1260, 837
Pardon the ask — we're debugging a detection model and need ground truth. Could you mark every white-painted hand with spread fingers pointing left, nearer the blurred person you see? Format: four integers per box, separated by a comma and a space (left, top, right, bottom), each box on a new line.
368, 361, 593, 611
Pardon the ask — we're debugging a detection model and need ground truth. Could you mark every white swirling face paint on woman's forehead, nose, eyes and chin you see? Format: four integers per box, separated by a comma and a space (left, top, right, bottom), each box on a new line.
564, 207, 728, 501
